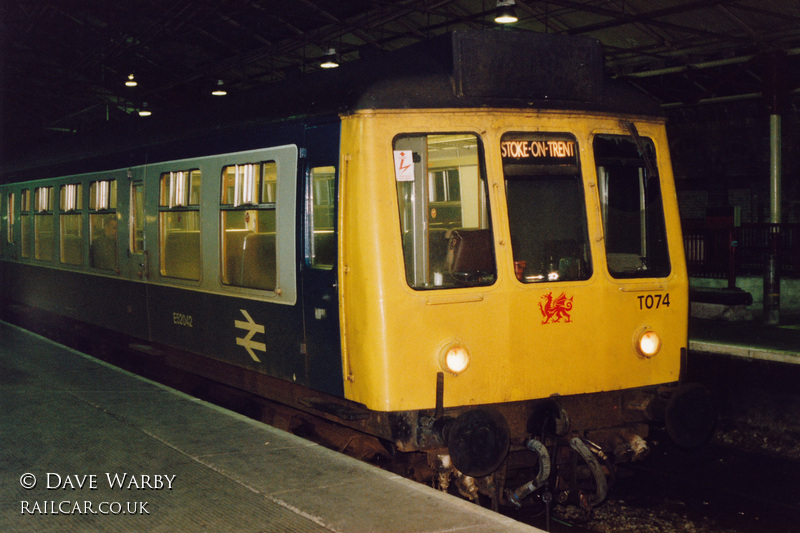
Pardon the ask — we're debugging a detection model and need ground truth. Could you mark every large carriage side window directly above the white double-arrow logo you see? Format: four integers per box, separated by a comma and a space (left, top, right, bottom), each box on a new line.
220, 161, 278, 290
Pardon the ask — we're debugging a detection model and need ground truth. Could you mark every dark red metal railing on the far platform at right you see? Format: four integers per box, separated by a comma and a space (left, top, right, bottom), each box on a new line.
683, 224, 800, 280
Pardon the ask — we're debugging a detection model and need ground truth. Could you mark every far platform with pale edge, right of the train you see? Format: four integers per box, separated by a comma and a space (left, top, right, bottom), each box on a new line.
689, 311, 800, 364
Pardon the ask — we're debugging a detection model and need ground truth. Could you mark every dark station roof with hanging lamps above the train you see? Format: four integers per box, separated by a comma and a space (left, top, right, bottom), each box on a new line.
0, 0, 800, 154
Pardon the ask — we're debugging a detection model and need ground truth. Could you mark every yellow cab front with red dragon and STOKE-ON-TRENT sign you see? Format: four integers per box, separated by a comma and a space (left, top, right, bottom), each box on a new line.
339, 109, 688, 411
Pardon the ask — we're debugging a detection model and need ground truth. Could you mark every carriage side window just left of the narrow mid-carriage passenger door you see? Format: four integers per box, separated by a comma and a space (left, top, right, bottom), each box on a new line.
89, 180, 119, 273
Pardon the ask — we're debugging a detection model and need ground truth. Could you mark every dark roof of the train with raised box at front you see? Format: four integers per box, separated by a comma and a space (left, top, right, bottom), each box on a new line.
0, 30, 662, 181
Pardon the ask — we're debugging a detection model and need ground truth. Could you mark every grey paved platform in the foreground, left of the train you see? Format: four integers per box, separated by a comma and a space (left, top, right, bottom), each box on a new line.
0, 322, 539, 533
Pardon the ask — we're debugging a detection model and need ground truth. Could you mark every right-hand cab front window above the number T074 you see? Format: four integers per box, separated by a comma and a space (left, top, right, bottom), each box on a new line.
594, 134, 671, 278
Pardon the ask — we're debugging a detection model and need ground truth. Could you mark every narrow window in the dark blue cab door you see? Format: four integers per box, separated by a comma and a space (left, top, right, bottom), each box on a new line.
306, 167, 337, 270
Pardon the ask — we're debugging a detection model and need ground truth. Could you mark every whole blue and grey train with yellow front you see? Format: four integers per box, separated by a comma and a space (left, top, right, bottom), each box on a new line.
0, 31, 713, 507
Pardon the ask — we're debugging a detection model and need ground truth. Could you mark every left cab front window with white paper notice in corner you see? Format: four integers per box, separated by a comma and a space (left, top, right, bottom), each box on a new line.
393, 134, 497, 289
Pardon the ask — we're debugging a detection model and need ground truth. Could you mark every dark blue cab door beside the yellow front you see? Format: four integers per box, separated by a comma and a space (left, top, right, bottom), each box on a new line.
302, 123, 344, 396
